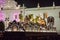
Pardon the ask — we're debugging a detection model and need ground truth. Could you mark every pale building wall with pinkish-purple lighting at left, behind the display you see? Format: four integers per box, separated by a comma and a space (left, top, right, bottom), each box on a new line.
0, 0, 60, 32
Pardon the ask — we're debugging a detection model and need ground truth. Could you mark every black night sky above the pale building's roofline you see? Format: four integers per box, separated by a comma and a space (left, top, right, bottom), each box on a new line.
15, 0, 60, 8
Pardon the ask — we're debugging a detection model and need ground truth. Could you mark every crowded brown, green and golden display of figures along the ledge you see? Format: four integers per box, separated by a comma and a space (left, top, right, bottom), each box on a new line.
6, 14, 54, 31
